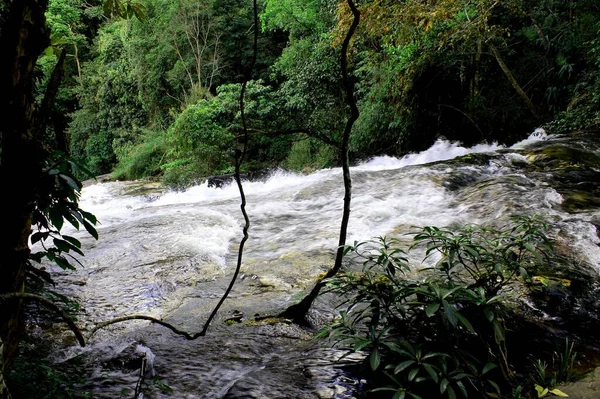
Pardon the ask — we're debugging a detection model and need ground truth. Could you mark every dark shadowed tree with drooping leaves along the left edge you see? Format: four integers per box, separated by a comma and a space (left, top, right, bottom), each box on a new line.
0, 0, 135, 384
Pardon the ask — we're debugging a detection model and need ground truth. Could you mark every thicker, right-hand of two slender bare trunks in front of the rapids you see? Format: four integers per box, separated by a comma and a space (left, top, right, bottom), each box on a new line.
281, 0, 360, 324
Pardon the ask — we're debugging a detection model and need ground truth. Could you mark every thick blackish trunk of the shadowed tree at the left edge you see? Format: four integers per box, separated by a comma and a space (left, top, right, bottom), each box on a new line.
0, 0, 50, 372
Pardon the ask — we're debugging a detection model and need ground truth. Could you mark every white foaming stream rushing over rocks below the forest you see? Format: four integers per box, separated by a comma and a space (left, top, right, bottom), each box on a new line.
42, 130, 600, 399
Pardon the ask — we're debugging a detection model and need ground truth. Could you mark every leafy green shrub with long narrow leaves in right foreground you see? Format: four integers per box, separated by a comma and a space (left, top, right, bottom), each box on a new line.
320, 217, 550, 399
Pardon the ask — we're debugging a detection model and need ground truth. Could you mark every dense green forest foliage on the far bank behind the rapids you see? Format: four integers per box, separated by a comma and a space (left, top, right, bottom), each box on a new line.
39, 0, 600, 183
